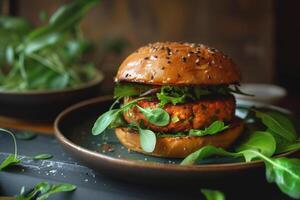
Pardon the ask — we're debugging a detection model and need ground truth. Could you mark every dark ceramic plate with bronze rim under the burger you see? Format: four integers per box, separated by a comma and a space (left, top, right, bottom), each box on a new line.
55, 97, 292, 184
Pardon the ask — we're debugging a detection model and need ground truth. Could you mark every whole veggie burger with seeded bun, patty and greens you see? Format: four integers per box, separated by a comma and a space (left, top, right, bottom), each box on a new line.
92, 42, 244, 158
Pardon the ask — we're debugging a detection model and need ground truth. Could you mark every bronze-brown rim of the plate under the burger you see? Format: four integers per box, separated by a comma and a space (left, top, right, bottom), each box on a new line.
54, 95, 297, 172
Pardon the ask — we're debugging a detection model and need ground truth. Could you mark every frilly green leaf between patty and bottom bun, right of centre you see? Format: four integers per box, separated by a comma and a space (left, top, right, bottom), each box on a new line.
189, 121, 229, 136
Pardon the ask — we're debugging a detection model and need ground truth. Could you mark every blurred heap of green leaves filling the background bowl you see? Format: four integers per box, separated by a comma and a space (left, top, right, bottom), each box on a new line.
0, 0, 127, 92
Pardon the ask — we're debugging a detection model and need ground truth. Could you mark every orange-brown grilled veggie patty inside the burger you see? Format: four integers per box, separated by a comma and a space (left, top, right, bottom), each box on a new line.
124, 95, 235, 133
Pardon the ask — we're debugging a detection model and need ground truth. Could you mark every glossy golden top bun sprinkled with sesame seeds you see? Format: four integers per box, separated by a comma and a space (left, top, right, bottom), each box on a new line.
115, 42, 241, 85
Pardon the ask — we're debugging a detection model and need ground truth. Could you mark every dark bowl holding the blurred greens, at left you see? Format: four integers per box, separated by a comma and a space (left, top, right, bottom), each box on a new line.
0, 72, 103, 121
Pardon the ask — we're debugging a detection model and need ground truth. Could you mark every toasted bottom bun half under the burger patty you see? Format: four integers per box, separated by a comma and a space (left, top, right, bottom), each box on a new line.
115, 117, 244, 158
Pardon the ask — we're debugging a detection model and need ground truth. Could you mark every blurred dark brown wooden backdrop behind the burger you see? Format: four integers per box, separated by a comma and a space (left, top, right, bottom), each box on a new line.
0, 0, 300, 95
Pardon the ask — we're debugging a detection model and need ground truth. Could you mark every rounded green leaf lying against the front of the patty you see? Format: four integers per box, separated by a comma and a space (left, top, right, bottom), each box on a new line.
137, 106, 170, 126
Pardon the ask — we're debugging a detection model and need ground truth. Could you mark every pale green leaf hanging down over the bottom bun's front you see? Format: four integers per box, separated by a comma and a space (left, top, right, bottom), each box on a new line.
138, 127, 156, 153
